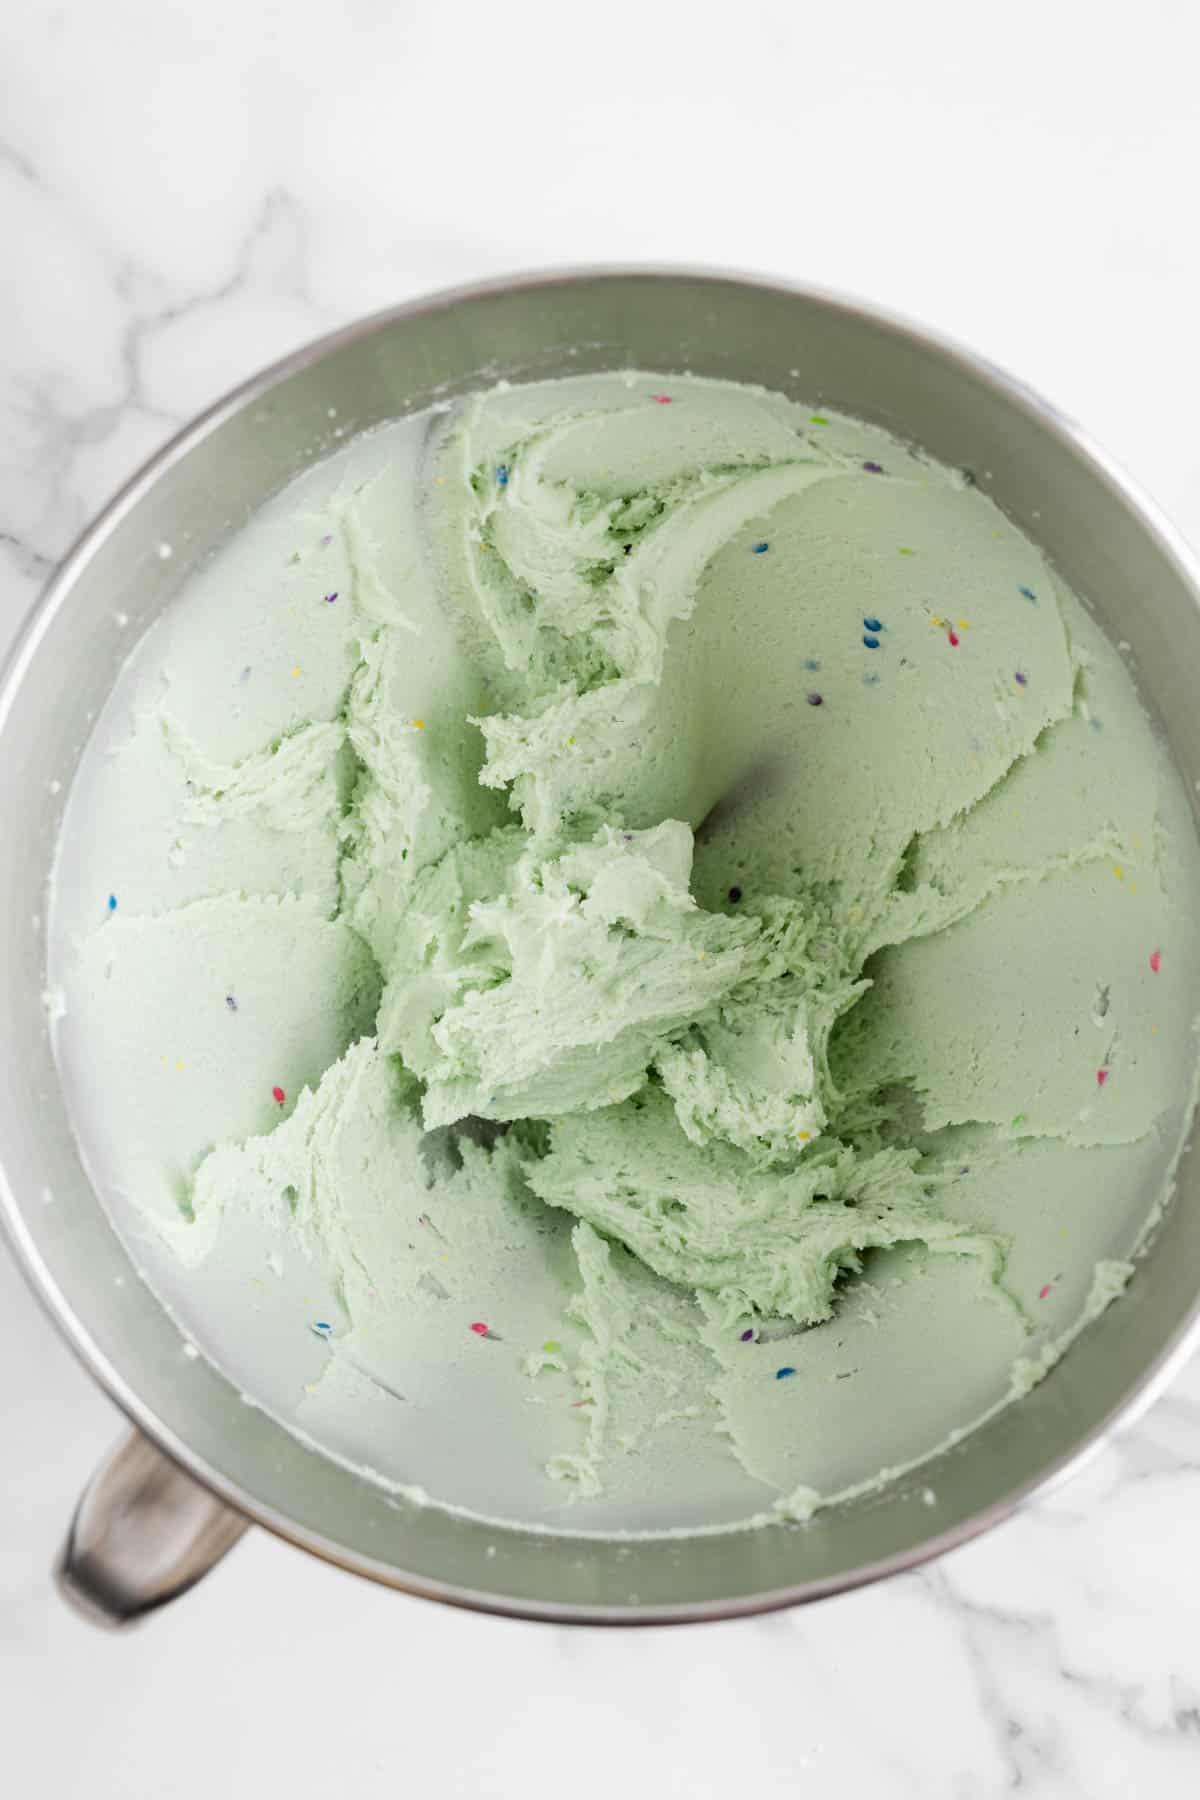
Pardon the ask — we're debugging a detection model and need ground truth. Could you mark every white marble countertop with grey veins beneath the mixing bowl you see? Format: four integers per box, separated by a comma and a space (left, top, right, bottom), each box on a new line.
0, 0, 1200, 1800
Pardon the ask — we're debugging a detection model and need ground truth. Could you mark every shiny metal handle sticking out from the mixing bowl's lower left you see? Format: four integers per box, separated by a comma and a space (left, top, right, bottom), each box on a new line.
54, 1431, 248, 1631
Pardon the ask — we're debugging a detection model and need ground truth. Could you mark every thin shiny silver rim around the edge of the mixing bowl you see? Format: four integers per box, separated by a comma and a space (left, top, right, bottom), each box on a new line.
0, 263, 1200, 1625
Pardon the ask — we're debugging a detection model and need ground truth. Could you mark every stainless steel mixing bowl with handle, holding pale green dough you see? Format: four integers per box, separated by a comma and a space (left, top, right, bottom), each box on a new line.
0, 270, 1200, 1624
